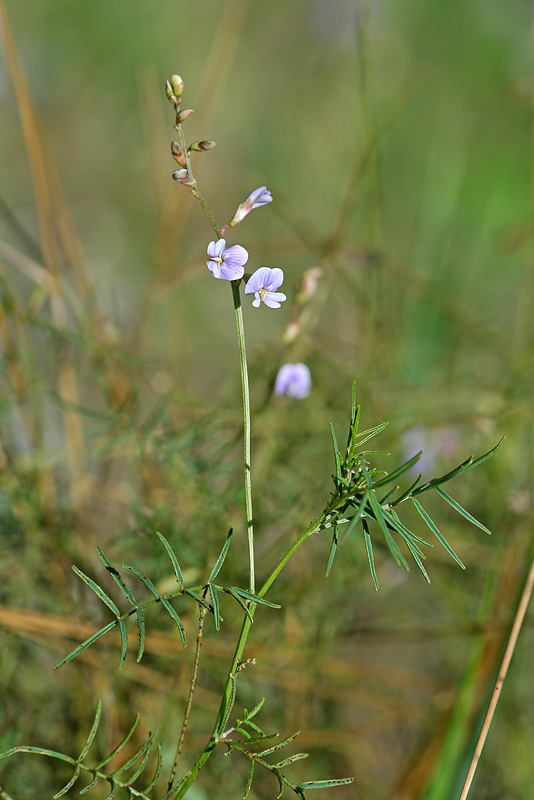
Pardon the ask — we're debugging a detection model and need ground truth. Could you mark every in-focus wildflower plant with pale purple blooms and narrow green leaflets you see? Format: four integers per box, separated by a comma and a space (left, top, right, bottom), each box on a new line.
0, 75, 502, 800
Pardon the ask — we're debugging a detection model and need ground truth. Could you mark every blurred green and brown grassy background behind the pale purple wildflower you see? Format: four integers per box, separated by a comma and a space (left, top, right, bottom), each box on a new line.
0, 0, 534, 800
